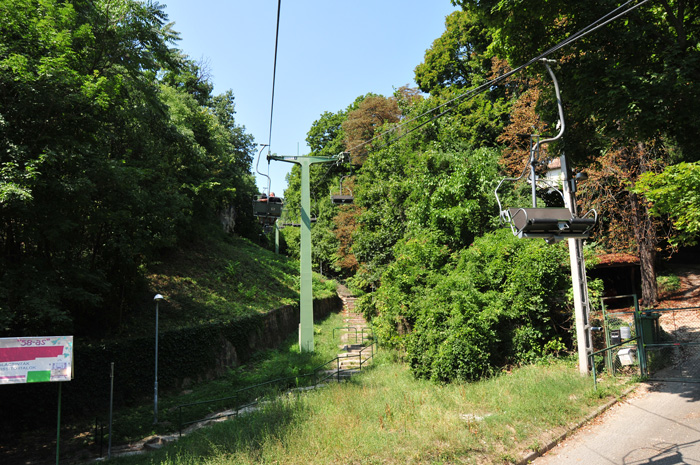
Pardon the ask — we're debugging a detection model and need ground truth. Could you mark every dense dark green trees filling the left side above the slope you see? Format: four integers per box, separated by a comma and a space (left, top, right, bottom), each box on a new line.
0, 0, 255, 335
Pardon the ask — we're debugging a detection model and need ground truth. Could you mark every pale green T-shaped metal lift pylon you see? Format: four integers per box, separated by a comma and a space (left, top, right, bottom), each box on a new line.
267, 152, 346, 352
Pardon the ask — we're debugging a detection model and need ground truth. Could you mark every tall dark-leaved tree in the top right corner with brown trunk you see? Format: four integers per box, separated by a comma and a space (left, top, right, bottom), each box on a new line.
453, 0, 700, 305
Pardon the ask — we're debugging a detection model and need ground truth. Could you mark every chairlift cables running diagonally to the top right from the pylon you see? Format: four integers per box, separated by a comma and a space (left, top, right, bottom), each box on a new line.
348, 0, 650, 156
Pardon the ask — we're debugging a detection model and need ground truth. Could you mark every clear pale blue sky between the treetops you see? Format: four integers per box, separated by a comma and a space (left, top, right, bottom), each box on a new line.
161, 0, 456, 195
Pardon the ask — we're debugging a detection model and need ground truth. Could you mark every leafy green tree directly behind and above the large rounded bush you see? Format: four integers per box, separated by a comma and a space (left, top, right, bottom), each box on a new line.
353, 140, 499, 292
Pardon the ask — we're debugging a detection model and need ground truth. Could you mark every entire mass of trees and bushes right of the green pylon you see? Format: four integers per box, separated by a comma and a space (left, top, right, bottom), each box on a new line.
276, 0, 700, 381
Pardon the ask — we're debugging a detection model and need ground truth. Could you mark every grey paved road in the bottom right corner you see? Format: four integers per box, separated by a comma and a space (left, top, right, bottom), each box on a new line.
532, 383, 700, 465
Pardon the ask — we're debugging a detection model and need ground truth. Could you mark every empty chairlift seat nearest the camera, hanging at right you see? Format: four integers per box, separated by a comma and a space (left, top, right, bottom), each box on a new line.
508, 208, 596, 242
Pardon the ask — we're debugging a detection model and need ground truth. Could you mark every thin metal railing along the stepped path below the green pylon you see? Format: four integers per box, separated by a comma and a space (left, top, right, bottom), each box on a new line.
175, 341, 377, 436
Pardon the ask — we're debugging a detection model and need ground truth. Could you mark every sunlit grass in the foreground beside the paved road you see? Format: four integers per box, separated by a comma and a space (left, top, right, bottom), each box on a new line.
110, 352, 621, 465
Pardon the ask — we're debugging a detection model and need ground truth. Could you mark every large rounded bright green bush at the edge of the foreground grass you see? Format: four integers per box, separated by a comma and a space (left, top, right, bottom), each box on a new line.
363, 230, 570, 382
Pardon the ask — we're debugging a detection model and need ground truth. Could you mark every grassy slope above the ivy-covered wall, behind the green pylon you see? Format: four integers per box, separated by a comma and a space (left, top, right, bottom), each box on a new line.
122, 237, 335, 336
